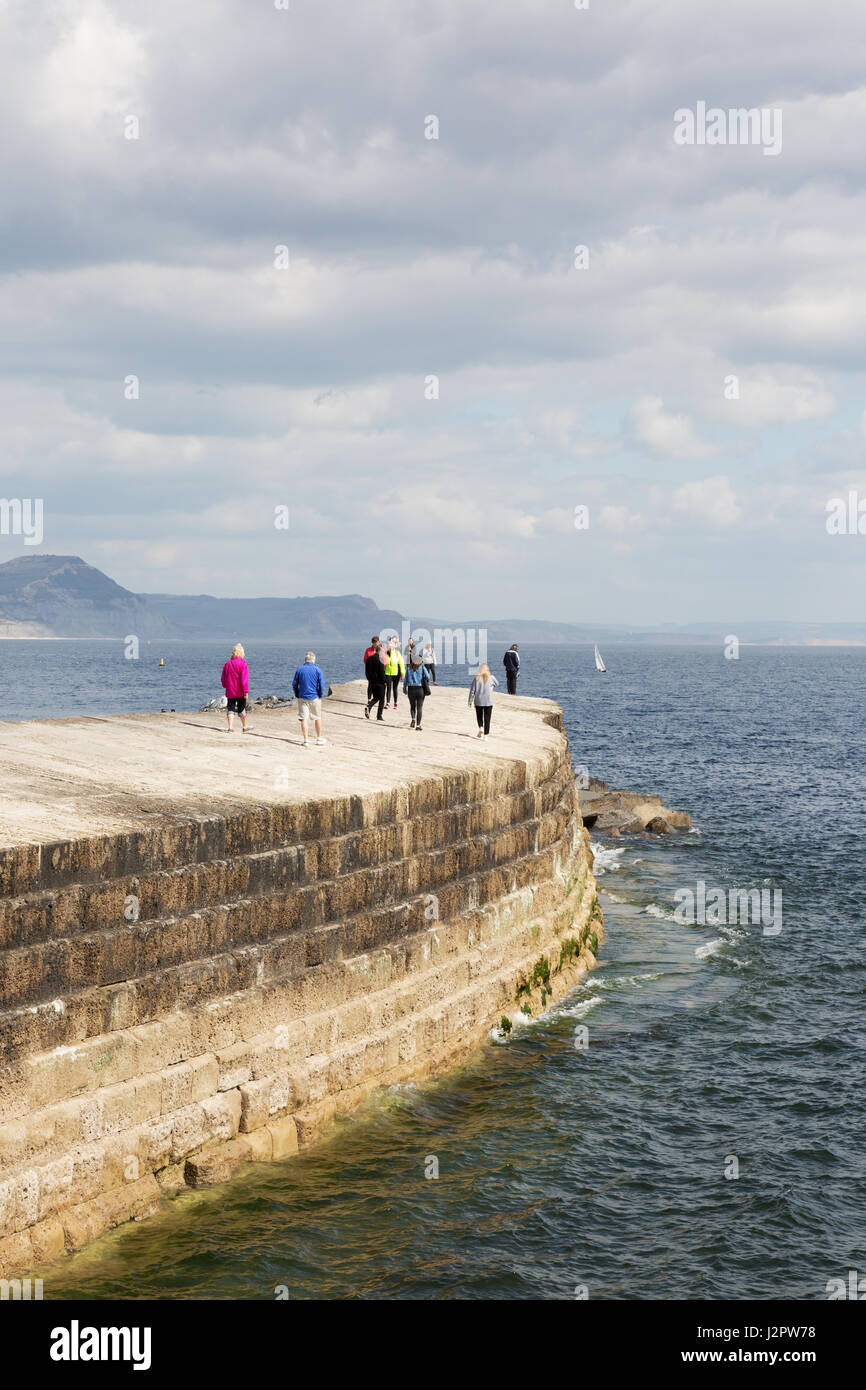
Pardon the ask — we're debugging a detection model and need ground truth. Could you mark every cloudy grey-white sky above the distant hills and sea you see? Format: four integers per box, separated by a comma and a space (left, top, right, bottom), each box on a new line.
0, 0, 866, 624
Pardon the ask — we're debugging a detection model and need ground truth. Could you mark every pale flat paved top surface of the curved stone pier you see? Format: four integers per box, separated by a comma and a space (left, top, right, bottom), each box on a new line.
0, 681, 562, 848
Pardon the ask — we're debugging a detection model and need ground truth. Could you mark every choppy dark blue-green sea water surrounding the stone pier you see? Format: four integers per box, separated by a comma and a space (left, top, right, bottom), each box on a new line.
8, 642, 866, 1300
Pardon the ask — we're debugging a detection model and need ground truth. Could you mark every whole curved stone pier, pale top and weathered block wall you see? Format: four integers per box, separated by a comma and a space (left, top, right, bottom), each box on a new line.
0, 681, 603, 1277
